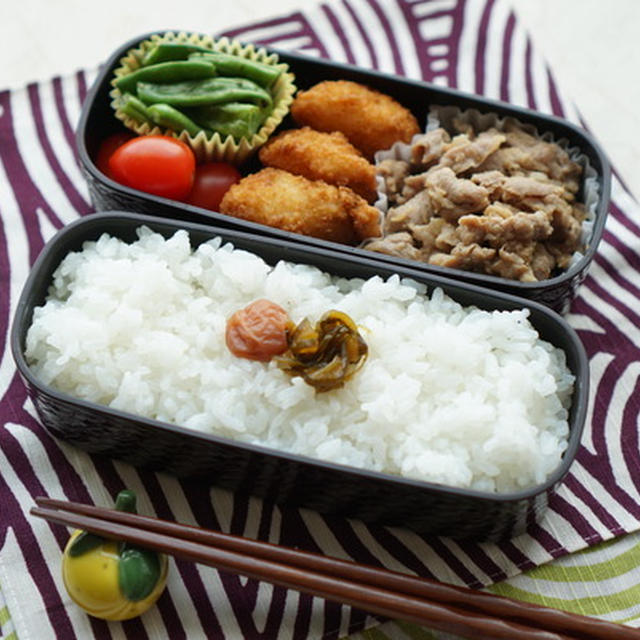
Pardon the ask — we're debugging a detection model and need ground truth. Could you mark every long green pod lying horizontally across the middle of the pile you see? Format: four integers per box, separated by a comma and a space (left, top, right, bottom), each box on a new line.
137, 77, 271, 107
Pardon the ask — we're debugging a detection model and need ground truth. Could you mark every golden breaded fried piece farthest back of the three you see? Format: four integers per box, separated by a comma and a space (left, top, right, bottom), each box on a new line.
291, 80, 420, 160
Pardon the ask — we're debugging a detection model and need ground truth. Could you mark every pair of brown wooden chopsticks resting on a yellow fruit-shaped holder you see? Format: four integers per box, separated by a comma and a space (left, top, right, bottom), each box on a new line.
31, 498, 640, 640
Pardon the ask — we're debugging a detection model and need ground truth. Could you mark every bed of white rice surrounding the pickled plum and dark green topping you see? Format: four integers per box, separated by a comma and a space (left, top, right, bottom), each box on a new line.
26, 228, 574, 492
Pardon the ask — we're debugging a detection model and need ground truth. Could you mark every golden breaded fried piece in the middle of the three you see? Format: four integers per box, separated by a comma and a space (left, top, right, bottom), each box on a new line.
260, 127, 376, 202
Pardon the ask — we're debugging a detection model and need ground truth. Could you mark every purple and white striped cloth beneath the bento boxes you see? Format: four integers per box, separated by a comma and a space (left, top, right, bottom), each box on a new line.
0, 0, 640, 640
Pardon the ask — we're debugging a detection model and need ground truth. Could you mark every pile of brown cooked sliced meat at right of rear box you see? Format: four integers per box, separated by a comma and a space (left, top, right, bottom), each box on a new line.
367, 123, 585, 282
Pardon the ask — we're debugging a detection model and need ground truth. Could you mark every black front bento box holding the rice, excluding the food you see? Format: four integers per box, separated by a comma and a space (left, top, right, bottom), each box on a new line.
11, 212, 589, 540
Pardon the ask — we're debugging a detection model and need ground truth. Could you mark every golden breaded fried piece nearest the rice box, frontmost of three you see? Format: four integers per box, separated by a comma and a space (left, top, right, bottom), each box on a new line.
220, 167, 380, 244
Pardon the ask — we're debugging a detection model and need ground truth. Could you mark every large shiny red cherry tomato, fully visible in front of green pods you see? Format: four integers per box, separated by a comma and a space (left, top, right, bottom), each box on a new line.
109, 136, 196, 200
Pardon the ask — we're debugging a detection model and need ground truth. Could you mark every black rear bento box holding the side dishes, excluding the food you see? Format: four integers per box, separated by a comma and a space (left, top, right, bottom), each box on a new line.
77, 34, 611, 313
